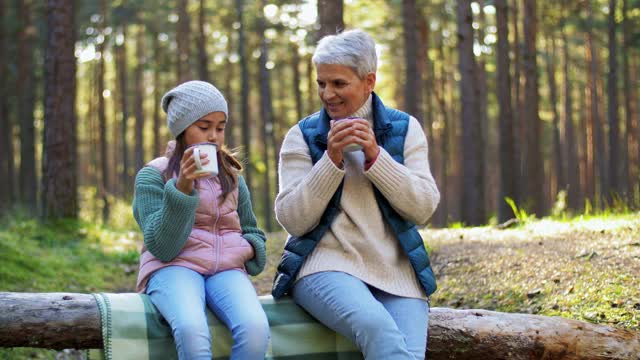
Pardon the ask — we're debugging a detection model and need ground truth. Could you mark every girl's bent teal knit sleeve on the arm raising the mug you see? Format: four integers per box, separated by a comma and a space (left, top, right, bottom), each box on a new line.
133, 166, 199, 262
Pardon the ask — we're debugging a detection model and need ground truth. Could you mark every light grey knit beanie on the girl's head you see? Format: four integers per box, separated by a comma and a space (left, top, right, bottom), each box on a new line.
162, 80, 229, 137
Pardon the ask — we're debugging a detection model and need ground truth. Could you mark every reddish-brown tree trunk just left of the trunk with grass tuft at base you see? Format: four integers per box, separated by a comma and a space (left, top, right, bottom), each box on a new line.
458, 0, 486, 225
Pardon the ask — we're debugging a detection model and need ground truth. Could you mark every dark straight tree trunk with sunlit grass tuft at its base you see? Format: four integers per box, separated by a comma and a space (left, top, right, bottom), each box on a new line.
495, 0, 519, 222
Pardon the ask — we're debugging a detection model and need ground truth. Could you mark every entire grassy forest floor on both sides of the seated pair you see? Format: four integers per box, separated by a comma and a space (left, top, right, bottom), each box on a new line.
0, 213, 640, 359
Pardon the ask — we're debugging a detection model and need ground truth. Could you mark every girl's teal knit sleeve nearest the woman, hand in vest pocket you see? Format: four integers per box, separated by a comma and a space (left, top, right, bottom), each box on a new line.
238, 176, 267, 276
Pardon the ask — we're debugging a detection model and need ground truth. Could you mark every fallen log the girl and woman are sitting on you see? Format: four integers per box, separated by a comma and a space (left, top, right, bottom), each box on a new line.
0, 292, 640, 360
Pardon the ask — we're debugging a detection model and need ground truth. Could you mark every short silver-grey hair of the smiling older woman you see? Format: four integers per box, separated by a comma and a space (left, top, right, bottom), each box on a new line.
311, 29, 378, 79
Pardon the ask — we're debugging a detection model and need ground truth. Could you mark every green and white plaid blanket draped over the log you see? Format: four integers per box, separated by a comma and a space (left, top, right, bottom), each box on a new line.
88, 293, 362, 360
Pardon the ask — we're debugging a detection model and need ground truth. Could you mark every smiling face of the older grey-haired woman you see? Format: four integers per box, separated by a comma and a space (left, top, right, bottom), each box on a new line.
316, 64, 376, 119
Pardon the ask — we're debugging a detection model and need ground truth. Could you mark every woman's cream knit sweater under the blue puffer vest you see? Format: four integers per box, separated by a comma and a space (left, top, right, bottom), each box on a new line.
275, 96, 440, 299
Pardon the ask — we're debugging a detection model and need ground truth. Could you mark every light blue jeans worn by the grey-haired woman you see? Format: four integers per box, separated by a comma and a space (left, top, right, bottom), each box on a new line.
293, 271, 429, 360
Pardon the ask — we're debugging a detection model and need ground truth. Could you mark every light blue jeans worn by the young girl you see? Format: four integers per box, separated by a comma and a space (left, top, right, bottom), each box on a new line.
147, 266, 269, 360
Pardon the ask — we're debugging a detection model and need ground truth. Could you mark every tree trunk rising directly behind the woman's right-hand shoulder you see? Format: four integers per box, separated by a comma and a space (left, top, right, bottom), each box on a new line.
402, 0, 424, 124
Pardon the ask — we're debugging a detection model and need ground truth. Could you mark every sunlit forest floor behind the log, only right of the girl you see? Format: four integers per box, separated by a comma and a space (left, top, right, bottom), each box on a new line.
254, 213, 640, 330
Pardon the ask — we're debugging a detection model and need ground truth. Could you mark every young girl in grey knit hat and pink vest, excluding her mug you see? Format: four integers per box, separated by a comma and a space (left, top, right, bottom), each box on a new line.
133, 81, 269, 360
